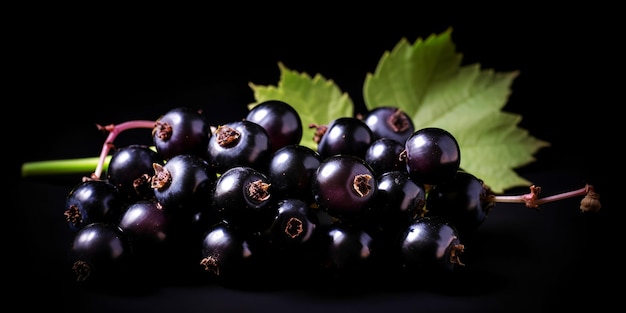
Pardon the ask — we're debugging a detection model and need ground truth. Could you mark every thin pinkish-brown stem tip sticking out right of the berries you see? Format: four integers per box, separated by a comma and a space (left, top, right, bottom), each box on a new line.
493, 184, 601, 212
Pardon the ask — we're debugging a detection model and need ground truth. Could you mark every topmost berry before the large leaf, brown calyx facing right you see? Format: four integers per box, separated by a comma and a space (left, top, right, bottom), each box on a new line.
363, 106, 415, 144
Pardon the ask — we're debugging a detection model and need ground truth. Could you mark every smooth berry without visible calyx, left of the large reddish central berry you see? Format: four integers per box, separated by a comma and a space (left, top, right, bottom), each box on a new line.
267, 145, 322, 203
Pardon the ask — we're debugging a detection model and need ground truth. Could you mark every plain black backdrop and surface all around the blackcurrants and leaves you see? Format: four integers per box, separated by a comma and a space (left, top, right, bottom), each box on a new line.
12, 7, 612, 312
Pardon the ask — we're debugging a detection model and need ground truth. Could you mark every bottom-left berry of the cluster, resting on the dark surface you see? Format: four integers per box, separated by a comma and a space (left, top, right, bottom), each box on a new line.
70, 223, 132, 283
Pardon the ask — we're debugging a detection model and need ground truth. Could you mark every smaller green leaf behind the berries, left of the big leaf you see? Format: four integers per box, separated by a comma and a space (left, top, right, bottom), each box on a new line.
248, 62, 354, 150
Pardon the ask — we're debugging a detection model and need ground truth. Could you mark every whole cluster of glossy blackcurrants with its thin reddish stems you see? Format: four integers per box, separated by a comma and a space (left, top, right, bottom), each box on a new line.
65, 100, 600, 287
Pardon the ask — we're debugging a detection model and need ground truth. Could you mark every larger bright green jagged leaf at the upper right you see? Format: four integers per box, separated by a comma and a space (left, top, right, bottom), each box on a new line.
363, 29, 550, 193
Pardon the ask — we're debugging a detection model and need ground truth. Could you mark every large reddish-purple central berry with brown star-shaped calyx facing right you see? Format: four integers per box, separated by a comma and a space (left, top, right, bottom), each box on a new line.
311, 154, 377, 218
